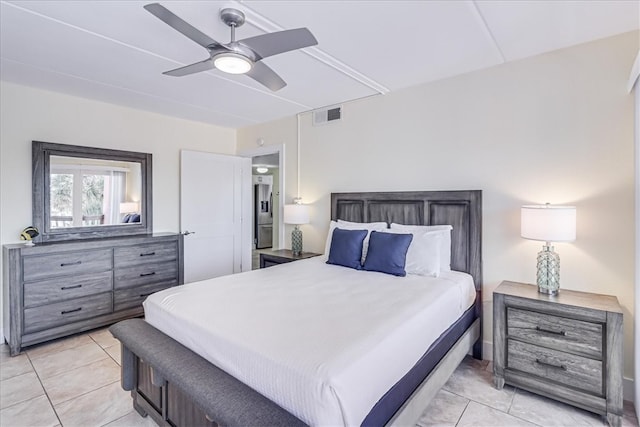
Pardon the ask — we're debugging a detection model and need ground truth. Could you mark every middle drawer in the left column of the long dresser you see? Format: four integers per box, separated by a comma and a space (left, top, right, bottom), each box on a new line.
24, 271, 113, 308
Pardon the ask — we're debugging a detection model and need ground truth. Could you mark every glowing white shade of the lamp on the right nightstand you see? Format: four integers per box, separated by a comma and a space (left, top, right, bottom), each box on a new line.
520, 205, 576, 242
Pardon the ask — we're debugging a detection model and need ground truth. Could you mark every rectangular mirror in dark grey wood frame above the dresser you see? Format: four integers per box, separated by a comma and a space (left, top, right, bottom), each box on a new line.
33, 141, 152, 242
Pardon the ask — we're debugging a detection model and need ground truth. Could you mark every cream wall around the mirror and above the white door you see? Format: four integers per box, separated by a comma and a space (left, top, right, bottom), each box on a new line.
0, 82, 236, 334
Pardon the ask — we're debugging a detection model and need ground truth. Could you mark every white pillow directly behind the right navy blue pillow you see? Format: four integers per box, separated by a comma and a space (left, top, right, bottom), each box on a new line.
385, 228, 444, 277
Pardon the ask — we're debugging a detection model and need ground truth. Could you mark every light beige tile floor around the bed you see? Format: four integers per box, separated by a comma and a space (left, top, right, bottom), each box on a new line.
0, 329, 638, 427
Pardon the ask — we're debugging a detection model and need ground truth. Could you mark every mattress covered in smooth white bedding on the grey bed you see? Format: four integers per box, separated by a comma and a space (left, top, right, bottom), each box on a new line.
144, 257, 476, 426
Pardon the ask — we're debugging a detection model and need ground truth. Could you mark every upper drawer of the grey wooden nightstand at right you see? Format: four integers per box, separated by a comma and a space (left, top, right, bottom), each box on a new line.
507, 307, 603, 359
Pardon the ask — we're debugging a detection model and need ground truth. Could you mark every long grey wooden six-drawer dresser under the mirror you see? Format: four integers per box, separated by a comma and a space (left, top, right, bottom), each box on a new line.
3, 233, 184, 356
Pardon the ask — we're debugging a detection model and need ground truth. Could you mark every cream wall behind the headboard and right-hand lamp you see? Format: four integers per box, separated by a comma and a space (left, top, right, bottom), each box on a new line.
238, 32, 639, 396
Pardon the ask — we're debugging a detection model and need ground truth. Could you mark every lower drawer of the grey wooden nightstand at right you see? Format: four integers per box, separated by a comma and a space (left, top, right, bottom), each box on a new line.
507, 339, 604, 396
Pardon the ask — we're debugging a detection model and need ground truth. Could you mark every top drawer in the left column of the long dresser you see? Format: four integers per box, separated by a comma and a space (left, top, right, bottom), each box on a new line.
23, 249, 113, 282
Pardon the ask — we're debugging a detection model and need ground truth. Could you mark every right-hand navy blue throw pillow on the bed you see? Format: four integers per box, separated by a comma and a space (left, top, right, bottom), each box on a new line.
362, 231, 413, 276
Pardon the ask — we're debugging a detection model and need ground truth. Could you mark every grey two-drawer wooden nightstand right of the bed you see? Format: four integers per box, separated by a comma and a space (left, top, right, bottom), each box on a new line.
493, 282, 623, 426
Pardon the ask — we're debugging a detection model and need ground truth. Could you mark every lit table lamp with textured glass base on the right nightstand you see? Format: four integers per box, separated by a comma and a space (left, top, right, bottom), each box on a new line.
520, 203, 576, 295
